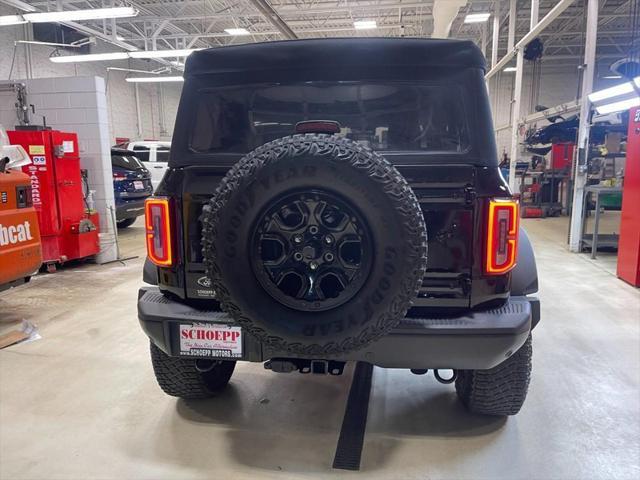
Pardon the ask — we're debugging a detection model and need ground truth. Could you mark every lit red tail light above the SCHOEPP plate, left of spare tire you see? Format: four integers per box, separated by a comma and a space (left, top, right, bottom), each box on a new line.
144, 197, 173, 267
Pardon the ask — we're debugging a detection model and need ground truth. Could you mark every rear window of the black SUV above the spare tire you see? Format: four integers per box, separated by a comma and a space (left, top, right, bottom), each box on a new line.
190, 82, 469, 153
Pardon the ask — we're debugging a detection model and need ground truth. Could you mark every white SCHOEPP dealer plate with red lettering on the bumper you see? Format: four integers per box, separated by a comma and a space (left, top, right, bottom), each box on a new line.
180, 323, 242, 358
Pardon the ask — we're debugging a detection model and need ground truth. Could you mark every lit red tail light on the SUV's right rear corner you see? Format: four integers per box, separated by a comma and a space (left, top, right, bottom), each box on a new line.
485, 199, 519, 275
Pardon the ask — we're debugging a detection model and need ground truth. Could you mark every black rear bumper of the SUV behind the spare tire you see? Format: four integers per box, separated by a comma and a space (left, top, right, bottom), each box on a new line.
138, 287, 540, 369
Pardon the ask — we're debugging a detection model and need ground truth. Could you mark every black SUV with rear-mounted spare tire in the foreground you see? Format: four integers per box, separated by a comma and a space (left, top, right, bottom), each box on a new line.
138, 39, 539, 415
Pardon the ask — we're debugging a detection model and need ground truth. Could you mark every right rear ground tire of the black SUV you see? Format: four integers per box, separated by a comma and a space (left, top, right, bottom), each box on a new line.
456, 335, 532, 415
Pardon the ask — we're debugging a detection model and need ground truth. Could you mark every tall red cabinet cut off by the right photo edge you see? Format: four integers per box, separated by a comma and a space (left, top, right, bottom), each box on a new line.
618, 108, 640, 287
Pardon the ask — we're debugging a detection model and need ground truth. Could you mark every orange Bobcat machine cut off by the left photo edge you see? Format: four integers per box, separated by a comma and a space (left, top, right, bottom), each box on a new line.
0, 127, 42, 291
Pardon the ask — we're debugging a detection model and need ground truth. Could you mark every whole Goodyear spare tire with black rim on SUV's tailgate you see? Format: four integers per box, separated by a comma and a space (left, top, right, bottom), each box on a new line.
202, 134, 427, 356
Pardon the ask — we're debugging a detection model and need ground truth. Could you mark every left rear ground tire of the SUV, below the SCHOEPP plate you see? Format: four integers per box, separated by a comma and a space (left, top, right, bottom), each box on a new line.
151, 343, 236, 399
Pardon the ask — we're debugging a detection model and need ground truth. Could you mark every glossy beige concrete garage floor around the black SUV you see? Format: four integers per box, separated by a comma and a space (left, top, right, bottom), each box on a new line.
0, 218, 640, 479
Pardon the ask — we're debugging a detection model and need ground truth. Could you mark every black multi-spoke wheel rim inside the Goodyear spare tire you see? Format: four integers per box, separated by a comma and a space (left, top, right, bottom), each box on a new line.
250, 190, 373, 312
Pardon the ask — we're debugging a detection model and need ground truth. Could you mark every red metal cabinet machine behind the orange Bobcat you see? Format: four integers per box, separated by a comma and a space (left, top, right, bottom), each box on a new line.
7, 130, 100, 270
